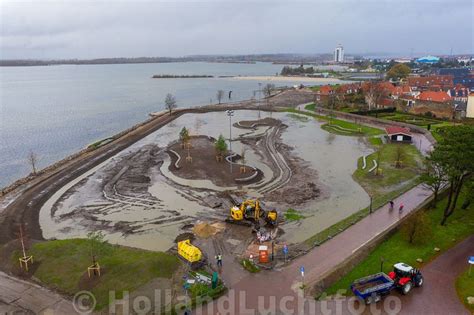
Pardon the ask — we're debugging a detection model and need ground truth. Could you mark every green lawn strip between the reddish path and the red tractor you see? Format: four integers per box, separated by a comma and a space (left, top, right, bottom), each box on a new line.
325, 190, 474, 295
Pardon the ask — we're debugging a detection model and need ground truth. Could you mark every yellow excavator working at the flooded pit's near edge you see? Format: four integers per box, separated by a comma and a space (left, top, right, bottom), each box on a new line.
226, 199, 278, 226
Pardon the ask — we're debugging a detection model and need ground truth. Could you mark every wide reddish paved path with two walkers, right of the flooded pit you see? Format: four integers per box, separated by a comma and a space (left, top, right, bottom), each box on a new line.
202, 185, 431, 314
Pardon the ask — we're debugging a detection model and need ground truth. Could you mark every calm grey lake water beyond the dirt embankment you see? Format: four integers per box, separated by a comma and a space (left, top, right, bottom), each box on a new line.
0, 62, 340, 187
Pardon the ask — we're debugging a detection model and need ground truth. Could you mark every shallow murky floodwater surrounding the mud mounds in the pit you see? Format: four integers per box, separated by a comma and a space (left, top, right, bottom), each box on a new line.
40, 110, 371, 250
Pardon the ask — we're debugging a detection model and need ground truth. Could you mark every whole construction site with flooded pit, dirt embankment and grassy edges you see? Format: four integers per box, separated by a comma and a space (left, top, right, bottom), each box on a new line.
0, 90, 440, 310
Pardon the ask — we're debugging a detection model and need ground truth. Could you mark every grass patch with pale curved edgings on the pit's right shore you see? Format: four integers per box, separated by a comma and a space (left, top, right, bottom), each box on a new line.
353, 143, 422, 197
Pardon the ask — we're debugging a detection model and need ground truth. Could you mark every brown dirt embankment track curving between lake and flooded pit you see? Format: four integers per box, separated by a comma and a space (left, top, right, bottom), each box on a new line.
0, 90, 314, 244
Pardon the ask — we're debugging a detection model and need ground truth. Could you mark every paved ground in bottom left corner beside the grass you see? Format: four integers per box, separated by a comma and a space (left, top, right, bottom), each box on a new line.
0, 272, 77, 315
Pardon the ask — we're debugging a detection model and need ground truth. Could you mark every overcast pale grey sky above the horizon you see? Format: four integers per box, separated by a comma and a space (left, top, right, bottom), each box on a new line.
0, 0, 474, 59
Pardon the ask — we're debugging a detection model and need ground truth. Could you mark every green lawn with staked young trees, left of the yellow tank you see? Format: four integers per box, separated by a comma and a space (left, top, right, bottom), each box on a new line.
12, 239, 179, 309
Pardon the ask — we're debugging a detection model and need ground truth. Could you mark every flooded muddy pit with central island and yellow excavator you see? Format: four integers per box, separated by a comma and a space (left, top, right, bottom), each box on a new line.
35, 105, 371, 274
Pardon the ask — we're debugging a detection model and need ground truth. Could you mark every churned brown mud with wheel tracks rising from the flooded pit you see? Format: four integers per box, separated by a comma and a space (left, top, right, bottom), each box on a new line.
42, 118, 321, 242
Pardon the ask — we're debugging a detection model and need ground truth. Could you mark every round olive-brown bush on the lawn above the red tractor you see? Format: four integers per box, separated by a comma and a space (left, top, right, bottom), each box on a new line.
400, 211, 433, 245
